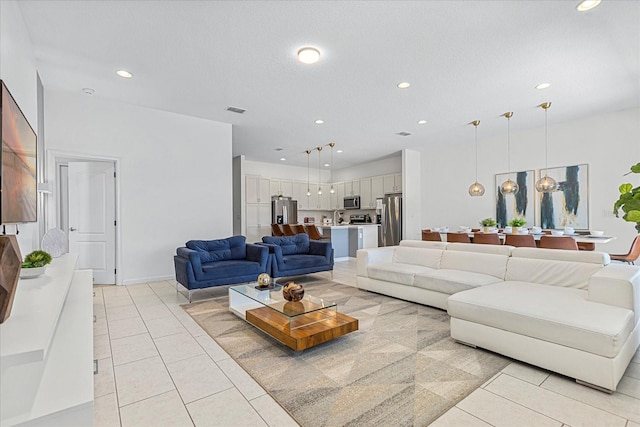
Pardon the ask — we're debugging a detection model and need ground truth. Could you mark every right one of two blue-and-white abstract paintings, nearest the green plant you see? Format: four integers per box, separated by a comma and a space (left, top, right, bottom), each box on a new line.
538, 164, 589, 230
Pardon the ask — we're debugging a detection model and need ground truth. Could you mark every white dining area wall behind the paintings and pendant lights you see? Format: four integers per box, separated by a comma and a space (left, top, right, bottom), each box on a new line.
422, 108, 640, 253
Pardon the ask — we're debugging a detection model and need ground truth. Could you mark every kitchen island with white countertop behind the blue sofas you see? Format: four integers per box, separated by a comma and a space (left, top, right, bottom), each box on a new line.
318, 224, 380, 260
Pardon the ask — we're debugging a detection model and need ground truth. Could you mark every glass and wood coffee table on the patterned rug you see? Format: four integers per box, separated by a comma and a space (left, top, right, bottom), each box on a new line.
229, 283, 358, 351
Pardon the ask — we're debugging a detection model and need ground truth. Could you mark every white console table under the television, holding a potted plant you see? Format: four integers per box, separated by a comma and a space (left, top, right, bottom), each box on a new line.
0, 254, 93, 427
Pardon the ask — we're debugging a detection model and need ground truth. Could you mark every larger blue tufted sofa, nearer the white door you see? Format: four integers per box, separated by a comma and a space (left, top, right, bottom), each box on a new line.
173, 236, 270, 302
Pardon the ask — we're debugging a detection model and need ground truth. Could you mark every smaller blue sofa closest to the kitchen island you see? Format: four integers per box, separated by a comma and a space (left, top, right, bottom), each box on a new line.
262, 234, 333, 278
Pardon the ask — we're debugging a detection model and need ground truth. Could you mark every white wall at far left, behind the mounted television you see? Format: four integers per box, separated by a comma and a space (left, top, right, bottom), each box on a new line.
0, 0, 40, 257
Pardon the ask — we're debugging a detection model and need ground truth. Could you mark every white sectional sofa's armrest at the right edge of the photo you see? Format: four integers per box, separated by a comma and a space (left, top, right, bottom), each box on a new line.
588, 264, 640, 323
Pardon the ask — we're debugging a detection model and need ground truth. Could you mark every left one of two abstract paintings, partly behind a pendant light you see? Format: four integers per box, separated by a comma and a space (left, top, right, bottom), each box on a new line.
495, 170, 535, 227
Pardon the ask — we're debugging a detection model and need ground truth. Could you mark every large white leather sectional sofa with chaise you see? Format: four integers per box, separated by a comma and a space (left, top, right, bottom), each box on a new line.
357, 241, 640, 391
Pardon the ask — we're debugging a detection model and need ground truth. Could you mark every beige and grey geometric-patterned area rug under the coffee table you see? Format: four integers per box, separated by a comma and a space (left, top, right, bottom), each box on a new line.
183, 276, 510, 427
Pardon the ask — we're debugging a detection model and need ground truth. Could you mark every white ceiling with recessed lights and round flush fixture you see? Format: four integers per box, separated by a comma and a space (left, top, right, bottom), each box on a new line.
19, 0, 640, 169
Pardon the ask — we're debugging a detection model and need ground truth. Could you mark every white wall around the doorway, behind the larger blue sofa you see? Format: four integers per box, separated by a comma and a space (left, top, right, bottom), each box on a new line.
45, 91, 233, 284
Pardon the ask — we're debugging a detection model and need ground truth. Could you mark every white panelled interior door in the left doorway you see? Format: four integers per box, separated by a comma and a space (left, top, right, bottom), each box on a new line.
69, 162, 116, 285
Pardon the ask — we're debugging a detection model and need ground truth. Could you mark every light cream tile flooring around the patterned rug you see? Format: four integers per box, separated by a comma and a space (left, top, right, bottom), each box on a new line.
94, 260, 640, 427
